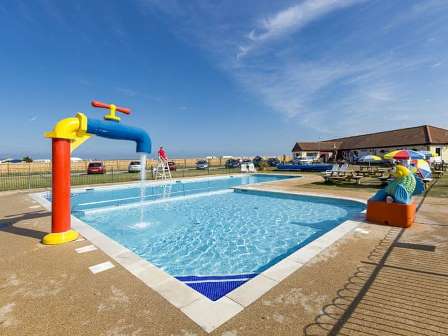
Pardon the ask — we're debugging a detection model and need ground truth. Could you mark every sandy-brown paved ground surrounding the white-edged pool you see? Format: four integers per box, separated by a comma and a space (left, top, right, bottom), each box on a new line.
0, 177, 448, 336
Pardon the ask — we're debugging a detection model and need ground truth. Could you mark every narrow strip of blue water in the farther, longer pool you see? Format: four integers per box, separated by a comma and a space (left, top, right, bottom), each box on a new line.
72, 174, 291, 211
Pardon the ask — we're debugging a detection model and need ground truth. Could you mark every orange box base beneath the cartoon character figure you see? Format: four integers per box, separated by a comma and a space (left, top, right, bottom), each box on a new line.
367, 201, 415, 228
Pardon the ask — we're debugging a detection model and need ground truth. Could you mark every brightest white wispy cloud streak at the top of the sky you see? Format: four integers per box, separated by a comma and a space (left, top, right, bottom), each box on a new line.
237, 0, 362, 58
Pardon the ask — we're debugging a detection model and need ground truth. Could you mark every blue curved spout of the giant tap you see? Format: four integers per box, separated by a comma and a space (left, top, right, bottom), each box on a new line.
87, 118, 151, 154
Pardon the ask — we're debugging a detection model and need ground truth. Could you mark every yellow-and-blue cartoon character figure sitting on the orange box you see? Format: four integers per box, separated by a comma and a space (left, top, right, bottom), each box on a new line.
370, 164, 422, 204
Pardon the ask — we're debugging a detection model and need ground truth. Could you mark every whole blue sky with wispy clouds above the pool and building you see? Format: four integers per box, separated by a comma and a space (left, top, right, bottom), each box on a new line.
0, 0, 448, 158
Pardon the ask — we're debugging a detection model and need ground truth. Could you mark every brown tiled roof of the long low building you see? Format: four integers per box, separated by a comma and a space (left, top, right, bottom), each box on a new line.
293, 125, 448, 152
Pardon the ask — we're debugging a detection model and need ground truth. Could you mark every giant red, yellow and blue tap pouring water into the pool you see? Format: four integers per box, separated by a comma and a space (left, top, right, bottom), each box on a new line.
42, 101, 151, 245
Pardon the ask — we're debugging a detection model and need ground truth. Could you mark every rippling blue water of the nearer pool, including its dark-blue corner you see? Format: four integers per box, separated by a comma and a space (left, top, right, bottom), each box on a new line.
77, 182, 364, 300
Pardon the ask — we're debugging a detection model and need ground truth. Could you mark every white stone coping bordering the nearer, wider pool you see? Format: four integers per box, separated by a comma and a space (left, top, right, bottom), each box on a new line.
29, 182, 366, 333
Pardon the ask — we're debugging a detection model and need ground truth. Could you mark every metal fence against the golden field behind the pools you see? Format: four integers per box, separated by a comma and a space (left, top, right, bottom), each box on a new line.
0, 159, 245, 191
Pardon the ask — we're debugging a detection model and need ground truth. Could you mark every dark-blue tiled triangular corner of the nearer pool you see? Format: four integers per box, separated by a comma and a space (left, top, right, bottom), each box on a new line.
176, 273, 258, 301
